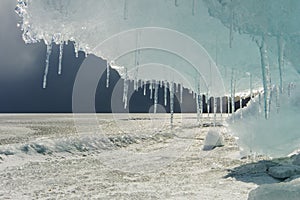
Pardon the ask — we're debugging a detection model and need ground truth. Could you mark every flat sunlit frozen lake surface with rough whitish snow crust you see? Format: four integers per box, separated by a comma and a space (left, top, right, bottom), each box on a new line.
0, 114, 278, 200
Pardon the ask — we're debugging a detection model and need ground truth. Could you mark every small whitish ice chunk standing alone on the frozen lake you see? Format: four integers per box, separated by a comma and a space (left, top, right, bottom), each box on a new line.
203, 130, 224, 151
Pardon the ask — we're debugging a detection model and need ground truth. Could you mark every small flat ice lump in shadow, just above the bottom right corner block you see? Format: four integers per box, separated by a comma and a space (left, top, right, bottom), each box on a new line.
268, 165, 300, 179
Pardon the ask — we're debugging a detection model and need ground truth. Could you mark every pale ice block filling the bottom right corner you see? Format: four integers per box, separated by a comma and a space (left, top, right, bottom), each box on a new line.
248, 178, 300, 200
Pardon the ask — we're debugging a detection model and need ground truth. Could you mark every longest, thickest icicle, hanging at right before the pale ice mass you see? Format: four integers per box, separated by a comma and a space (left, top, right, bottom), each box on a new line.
259, 37, 271, 119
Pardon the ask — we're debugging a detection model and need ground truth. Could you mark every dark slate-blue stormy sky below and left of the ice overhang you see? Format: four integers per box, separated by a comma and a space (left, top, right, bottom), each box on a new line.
0, 0, 195, 113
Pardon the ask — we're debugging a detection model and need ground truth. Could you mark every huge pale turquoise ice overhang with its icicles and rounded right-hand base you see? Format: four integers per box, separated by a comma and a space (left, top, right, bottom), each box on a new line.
16, 0, 300, 155
